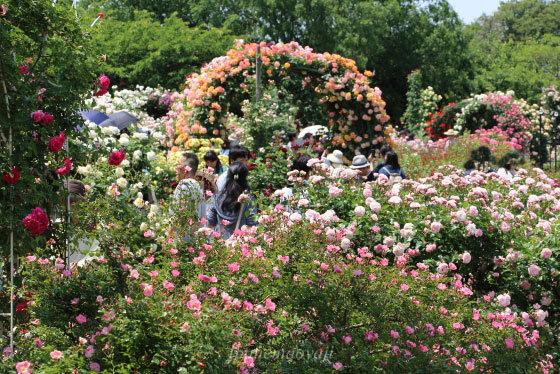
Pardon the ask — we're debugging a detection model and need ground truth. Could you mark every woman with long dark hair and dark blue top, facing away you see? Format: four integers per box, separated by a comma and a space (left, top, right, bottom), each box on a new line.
208, 161, 256, 239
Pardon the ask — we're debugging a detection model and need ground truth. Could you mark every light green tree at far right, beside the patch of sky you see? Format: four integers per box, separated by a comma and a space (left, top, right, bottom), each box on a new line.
466, 0, 560, 102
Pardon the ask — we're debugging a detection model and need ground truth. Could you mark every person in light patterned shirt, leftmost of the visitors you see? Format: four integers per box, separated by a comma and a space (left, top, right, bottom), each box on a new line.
173, 152, 205, 219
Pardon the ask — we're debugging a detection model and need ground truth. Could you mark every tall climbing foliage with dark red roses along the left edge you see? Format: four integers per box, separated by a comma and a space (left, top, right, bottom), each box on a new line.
0, 0, 99, 262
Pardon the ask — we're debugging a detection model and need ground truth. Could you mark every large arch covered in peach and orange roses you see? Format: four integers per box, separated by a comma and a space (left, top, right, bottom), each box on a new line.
169, 41, 389, 152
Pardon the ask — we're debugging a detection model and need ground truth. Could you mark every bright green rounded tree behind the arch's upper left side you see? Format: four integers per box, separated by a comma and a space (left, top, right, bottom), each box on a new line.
87, 8, 235, 88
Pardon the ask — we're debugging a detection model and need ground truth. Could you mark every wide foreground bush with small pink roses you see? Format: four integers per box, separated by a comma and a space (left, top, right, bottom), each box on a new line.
4, 197, 552, 373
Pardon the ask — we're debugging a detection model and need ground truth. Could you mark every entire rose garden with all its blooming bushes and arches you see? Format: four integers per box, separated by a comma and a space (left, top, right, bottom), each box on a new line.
0, 0, 560, 374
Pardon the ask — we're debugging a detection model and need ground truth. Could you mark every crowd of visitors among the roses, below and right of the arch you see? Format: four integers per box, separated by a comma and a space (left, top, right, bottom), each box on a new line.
174, 132, 522, 239
